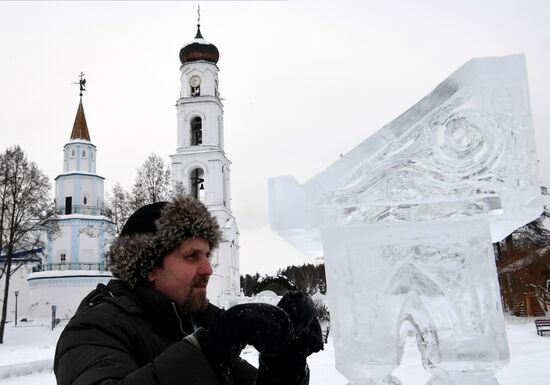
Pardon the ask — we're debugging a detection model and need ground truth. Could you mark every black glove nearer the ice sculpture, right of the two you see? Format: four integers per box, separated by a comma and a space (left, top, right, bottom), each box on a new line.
256, 292, 323, 385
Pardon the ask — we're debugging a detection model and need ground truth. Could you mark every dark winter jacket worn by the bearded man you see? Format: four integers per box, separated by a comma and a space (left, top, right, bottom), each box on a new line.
54, 280, 256, 385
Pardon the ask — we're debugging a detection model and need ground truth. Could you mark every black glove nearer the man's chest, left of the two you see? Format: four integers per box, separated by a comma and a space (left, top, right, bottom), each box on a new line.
193, 303, 294, 377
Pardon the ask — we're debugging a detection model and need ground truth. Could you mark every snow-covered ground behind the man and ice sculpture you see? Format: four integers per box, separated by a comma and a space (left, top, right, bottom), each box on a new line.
0, 318, 550, 385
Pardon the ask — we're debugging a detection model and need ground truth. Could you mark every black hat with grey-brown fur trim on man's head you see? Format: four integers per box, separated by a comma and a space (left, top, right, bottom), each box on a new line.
107, 195, 221, 287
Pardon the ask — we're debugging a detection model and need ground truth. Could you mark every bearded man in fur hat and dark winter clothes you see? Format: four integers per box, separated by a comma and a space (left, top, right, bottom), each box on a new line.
54, 196, 323, 385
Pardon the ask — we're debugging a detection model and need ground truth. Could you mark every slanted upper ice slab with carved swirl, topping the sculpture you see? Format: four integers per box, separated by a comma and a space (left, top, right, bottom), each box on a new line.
270, 54, 542, 254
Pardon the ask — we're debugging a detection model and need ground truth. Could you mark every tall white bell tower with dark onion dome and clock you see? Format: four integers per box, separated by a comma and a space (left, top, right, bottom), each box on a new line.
171, 24, 240, 304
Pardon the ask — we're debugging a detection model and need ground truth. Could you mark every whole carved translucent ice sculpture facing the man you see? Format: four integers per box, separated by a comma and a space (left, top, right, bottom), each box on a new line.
269, 55, 542, 385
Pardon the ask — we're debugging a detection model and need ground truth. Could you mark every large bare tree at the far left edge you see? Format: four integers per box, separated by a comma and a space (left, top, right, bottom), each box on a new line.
0, 146, 55, 343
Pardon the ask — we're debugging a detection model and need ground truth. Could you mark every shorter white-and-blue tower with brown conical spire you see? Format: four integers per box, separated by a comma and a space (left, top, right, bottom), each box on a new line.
27, 95, 113, 318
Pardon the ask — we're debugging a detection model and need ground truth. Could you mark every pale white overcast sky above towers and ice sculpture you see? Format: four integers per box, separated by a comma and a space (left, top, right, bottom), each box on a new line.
0, 0, 550, 274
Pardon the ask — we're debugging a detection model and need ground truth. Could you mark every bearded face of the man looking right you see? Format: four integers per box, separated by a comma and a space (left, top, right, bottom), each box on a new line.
147, 238, 212, 312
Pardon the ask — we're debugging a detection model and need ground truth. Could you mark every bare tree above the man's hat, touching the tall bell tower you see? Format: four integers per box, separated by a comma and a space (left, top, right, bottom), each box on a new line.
131, 153, 171, 209
